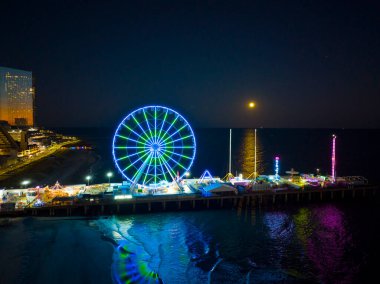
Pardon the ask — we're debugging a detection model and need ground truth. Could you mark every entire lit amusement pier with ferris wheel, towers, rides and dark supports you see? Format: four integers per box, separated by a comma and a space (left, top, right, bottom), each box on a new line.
0, 106, 378, 216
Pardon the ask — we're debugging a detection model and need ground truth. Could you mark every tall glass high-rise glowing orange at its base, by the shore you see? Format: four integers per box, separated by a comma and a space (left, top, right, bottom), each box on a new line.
0, 67, 34, 126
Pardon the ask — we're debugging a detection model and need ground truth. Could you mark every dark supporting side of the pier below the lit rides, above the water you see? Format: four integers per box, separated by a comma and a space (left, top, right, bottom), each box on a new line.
0, 186, 379, 217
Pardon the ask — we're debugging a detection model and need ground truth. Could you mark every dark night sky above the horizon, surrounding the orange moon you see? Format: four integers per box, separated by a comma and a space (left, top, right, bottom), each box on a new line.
0, 0, 380, 128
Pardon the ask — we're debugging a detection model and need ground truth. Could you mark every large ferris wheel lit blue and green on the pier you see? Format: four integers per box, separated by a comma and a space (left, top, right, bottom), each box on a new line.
112, 106, 196, 185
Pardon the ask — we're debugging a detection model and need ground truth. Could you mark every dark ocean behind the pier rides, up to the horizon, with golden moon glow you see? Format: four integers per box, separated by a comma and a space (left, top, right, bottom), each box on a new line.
55, 128, 380, 183
